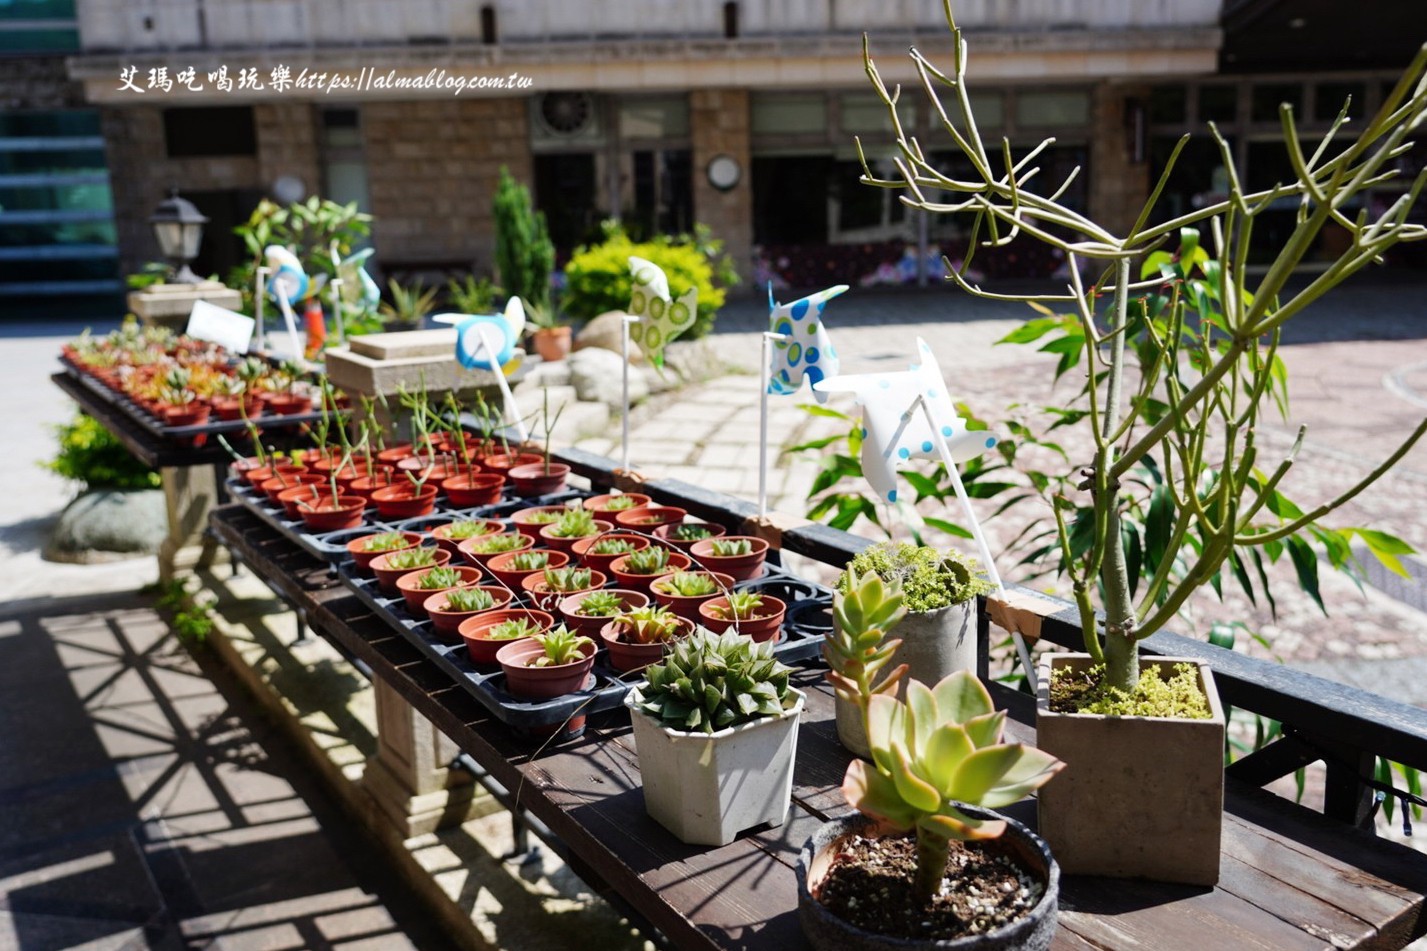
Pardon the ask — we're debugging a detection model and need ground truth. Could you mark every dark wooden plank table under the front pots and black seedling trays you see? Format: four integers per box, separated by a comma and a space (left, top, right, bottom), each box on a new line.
213, 508, 1427, 951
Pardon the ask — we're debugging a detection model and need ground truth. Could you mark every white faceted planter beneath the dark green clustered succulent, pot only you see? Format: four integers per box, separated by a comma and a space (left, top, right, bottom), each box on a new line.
625, 690, 803, 845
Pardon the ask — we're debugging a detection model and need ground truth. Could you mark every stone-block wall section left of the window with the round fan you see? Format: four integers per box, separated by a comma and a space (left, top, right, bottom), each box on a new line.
362, 99, 532, 274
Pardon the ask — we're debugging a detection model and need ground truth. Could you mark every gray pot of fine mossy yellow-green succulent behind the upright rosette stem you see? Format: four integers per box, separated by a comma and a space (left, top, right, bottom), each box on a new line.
828, 541, 992, 757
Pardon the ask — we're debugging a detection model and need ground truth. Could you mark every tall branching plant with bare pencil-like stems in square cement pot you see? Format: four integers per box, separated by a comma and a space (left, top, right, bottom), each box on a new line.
858, 0, 1427, 691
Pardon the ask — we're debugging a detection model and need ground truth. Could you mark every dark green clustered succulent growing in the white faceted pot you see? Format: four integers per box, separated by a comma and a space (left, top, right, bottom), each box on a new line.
635, 631, 796, 733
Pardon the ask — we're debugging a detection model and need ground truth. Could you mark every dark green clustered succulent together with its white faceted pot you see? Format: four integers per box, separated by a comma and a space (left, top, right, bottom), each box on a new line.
625, 631, 803, 845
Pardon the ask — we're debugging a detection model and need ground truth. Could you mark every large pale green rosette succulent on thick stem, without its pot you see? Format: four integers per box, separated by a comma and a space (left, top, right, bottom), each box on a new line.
842, 670, 1065, 901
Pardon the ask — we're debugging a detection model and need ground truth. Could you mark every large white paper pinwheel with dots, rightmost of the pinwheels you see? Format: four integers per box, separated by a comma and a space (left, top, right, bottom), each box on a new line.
813, 337, 996, 503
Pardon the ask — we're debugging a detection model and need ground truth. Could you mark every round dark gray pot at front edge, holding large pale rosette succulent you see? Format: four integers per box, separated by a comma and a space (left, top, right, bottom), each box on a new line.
796, 805, 1060, 951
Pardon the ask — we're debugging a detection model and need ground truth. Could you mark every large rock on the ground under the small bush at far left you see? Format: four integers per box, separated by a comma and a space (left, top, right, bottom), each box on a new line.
44, 488, 168, 561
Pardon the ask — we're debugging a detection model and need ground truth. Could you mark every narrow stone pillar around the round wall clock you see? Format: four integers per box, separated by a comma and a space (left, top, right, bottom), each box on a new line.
689, 89, 753, 281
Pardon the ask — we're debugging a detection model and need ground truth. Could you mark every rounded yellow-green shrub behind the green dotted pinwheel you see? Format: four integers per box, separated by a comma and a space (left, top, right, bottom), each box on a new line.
562, 228, 736, 340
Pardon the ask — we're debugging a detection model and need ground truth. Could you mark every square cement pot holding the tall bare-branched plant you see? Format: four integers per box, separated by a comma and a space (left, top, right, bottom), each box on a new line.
1036, 654, 1224, 885
